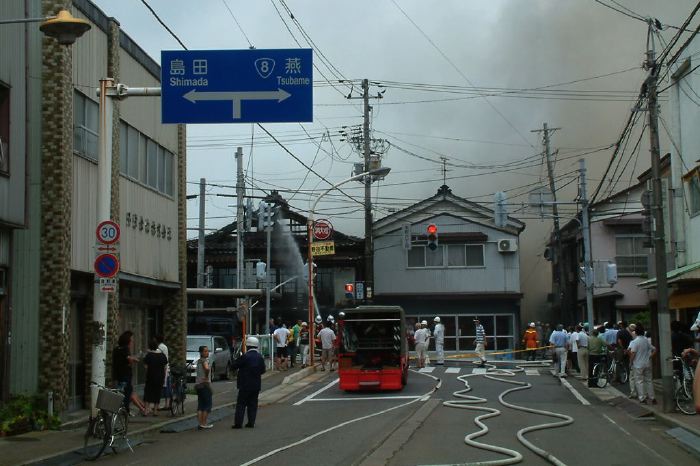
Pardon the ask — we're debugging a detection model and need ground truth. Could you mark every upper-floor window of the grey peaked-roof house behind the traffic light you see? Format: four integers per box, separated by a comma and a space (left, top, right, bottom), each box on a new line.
408, 244, 484, 268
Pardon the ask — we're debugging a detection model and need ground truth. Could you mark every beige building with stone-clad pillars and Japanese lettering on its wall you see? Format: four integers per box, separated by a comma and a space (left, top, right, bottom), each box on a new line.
0, 0, 186, 410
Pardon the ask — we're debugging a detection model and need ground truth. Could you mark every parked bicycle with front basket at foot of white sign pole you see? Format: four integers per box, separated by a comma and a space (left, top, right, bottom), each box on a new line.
83, 382, 134, 460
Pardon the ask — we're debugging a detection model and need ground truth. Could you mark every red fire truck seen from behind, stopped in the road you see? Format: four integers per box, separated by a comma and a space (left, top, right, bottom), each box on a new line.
338, 306, 408, 391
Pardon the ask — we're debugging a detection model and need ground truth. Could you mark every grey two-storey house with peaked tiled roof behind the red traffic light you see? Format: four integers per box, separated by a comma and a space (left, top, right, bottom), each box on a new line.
372, 185, 525, 351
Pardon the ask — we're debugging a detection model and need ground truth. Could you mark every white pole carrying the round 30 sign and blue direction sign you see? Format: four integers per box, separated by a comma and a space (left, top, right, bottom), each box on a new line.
91, 78, 116, 416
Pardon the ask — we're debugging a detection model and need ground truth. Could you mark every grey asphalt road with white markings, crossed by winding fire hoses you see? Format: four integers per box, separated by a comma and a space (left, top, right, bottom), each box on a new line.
85, 364, 698, 466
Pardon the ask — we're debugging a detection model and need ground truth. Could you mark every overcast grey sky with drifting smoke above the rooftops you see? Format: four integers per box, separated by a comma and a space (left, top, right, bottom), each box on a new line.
93, 0, 697, 240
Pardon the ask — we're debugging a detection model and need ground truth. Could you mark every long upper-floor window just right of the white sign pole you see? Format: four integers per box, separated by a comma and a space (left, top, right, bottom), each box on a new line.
119, 121, 175, 196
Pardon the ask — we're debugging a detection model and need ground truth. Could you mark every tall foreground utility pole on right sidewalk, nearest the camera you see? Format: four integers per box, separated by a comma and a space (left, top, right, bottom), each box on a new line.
644, 20, 673, 413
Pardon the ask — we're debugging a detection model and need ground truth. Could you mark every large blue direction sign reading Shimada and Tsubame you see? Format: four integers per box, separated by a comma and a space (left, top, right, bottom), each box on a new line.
161, 49, 313, 123
